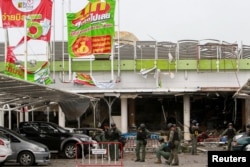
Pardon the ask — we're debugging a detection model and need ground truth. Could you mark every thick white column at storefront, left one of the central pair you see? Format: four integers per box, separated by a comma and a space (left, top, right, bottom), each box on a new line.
121, 98, 128, 133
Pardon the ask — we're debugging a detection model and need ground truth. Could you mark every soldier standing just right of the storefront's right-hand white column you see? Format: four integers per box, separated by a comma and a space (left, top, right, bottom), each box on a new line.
189, 120, 199, 155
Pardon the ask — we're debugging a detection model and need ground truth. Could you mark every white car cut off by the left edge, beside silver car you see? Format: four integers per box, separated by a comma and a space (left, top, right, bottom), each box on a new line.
0, 132, 12, 166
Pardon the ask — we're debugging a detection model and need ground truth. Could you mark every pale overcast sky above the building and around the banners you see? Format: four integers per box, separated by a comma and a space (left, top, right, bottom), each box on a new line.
0, 0, 250, 54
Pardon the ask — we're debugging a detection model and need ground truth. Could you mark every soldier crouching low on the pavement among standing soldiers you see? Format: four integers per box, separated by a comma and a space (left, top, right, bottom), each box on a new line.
155, 137, 170, 164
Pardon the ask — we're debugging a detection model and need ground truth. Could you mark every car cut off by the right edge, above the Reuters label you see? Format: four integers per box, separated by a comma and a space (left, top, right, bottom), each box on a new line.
231, 133, 250, 151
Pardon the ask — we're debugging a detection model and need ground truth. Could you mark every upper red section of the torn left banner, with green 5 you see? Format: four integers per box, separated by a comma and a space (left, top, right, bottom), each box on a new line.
1, 0, 53, 41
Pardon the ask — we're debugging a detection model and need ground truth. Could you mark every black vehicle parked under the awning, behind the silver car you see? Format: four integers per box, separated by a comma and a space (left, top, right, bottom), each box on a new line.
19, 121, 95, 159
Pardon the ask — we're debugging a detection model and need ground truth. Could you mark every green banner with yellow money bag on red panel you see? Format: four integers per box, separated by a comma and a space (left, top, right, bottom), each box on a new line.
67, 0, 116, 58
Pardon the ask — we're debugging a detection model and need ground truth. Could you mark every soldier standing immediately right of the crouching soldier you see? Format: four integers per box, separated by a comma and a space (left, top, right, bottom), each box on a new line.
166, 123, 180, 166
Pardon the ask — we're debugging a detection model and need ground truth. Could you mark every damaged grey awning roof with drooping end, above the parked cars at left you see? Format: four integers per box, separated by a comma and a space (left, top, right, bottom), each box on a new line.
0, 74, 95, 120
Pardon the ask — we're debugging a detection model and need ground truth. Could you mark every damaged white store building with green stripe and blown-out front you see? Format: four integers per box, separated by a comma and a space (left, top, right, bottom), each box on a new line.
0, 39, 250, 139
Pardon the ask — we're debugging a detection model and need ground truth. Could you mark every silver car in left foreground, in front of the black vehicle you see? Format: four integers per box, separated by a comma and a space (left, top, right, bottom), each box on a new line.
0, 126, 50, 166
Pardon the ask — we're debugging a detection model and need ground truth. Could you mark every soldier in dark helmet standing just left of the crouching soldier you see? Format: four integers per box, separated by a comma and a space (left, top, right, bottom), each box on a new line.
135, 123, 150, 162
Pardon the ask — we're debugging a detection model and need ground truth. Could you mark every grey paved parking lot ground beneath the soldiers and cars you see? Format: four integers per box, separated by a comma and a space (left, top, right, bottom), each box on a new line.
1, 146, 223, 167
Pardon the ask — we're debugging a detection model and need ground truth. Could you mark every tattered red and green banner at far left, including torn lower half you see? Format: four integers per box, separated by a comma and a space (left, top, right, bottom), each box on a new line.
0, 0, 53, 84
